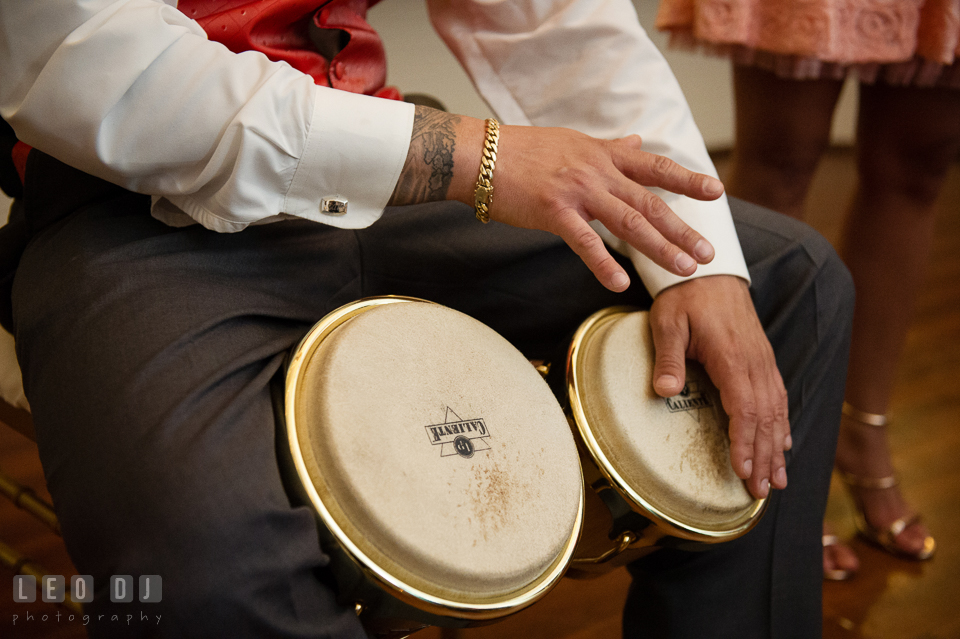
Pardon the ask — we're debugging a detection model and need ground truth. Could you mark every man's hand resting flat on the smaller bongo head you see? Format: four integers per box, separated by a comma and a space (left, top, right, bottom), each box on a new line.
650, 275, 792, 497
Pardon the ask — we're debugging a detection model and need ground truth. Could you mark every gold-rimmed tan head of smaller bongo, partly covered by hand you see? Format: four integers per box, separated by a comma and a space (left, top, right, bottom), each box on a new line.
568, 308, 765, 541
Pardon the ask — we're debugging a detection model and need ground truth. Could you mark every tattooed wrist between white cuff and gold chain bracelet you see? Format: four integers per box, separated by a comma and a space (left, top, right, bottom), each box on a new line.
390, 106, 460, 206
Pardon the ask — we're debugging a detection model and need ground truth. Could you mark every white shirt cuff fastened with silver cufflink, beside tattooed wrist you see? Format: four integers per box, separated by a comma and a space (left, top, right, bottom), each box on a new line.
283, 87, 415, 229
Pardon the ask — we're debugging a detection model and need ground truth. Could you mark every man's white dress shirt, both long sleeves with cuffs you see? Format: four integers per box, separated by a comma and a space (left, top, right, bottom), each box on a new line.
0, 0, 749, 295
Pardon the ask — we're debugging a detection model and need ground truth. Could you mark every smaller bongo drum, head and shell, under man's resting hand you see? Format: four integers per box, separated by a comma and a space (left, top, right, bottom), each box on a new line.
566, 307, 766, 577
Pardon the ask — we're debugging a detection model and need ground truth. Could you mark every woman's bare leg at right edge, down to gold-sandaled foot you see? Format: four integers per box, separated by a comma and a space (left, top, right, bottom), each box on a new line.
837, 84, 960, 554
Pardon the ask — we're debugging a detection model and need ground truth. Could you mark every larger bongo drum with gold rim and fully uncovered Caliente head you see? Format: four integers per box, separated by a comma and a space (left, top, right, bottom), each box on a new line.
277, 297, 583, 637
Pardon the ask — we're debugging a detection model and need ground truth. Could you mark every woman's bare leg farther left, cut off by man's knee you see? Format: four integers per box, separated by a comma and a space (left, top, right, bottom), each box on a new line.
727, 65, 843, 219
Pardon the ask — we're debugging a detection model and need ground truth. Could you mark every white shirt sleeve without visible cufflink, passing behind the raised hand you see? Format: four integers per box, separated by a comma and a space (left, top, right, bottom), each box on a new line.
428, 0, 750, 295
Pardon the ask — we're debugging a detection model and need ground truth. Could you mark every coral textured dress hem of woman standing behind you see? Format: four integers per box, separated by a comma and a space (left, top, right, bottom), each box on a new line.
657, 0, 960, 88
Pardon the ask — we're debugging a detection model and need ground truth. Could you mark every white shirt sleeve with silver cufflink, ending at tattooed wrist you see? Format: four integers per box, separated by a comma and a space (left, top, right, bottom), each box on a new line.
0, 0, 414, 231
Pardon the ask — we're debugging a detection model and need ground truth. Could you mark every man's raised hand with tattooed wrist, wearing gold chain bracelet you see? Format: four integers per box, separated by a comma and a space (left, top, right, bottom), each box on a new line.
390, 107, 723, 291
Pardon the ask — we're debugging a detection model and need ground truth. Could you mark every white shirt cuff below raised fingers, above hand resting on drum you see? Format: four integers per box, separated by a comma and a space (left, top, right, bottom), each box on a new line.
593, 189, 750, 297
